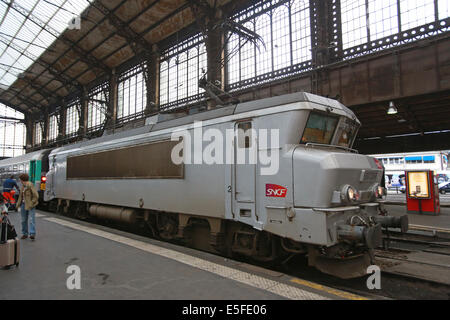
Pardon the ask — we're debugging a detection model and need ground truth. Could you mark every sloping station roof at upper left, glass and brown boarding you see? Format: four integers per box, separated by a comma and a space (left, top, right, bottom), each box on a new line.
0, 0, 229, 113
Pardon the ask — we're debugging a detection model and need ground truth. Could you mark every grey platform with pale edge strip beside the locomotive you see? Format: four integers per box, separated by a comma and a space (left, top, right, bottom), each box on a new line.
0, 211, 364, 300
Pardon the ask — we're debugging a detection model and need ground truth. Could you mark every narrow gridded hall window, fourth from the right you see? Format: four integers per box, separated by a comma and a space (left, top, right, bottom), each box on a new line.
117, 65, 147, 120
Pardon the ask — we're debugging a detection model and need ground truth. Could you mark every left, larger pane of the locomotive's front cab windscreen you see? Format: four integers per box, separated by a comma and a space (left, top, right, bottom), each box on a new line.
301, 112, 338, 144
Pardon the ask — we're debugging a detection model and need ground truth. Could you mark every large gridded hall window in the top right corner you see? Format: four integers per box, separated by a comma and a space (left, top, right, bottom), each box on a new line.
340, 0, 450, 59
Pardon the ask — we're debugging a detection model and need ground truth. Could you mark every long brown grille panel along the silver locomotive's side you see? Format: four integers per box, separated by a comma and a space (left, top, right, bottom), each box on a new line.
67, 141, 184, 180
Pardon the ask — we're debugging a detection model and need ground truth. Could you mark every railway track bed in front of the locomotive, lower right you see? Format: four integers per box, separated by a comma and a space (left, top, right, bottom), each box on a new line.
278, 238, 450, 300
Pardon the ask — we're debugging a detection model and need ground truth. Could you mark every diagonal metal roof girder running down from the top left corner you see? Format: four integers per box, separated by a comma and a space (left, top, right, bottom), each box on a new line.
1, 0, 111, 74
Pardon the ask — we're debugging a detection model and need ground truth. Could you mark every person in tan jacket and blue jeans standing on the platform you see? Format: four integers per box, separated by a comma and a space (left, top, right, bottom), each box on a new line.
17, 173, 39, 240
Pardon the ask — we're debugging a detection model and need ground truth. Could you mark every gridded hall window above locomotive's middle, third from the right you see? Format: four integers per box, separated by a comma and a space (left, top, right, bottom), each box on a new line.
159, 35, 207, 110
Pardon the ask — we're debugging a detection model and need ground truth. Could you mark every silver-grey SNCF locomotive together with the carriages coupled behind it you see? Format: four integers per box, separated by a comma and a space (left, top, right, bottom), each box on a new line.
0, 92, 408, 278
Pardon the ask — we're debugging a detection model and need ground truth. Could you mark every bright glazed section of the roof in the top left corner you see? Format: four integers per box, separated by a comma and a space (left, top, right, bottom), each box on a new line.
0, 0, 89, 90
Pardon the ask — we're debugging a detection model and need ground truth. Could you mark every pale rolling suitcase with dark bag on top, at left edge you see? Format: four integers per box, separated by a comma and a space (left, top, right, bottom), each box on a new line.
0, 217, 20, 268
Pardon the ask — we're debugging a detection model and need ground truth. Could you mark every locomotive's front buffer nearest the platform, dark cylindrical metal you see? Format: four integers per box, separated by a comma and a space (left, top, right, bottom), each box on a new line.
337, 224, 383, 249
